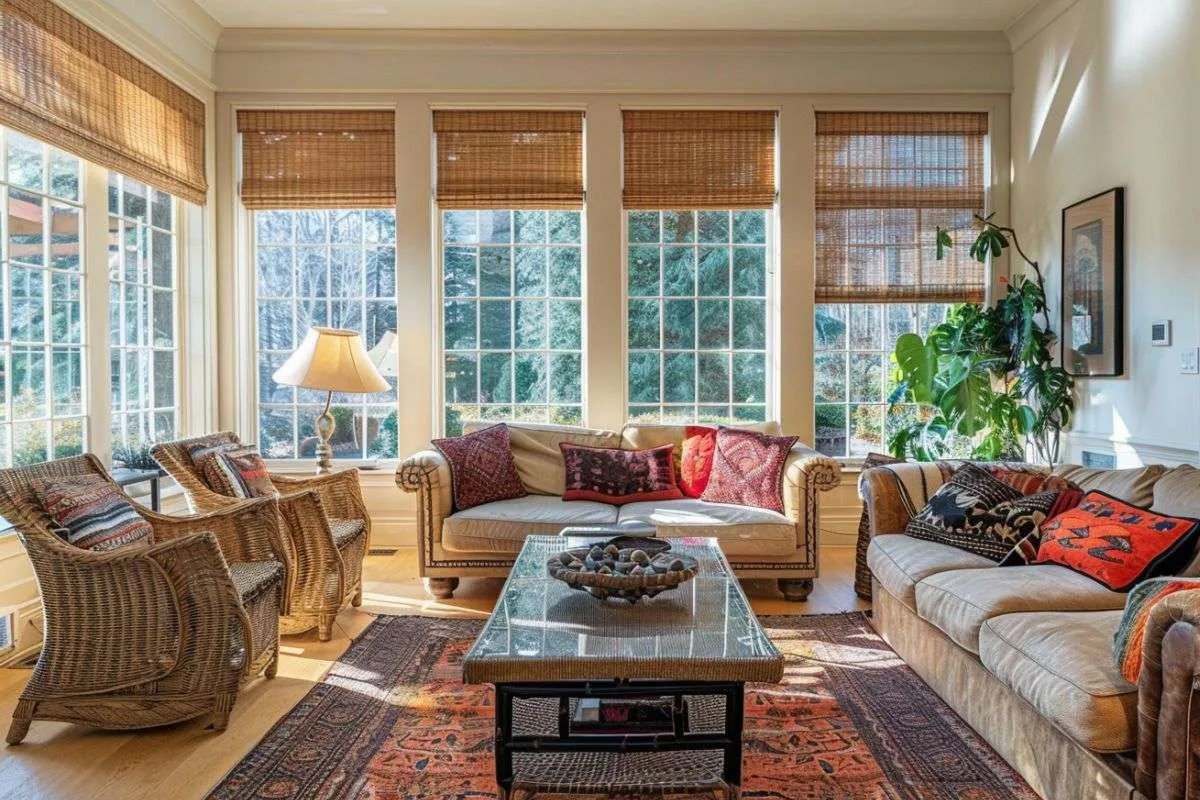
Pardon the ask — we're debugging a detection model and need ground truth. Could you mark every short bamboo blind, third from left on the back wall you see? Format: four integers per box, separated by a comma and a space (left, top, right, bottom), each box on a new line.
622, 110, 775, 209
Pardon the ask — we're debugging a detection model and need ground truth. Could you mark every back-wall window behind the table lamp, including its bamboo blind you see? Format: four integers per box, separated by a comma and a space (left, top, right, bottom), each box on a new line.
238, 110, 398, 459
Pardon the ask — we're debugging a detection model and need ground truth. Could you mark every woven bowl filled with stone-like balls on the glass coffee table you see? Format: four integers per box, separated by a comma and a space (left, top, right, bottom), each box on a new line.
546, 536, 698, 603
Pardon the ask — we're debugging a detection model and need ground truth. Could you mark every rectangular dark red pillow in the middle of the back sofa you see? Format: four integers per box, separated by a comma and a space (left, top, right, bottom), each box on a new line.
558, 441, 683, 505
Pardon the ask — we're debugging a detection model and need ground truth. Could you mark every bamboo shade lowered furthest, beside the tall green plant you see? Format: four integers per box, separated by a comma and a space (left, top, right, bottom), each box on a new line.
816, 112, 988, 302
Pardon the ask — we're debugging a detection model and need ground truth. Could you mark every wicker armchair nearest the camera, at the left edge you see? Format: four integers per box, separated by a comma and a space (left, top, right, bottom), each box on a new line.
0, 455, 286, 745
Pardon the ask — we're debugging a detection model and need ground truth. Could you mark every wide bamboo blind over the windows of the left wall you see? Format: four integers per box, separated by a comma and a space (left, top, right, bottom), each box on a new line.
0, 0, 208, 203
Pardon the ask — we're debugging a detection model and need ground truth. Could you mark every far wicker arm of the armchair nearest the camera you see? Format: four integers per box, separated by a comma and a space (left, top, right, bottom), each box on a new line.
138, 498, 289, 564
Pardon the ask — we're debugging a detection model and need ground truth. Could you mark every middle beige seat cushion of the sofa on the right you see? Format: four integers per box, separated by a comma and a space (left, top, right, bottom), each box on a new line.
917, 565, 1124, 652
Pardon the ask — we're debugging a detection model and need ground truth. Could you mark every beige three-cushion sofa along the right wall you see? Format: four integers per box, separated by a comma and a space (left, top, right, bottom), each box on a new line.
860, 464, 1200, 800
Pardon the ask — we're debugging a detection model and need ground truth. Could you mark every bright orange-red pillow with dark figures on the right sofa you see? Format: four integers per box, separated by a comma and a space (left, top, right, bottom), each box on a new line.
1038, 492, 1200, 591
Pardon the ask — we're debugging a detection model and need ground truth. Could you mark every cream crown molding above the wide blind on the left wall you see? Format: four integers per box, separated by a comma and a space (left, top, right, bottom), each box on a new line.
55, 0, 216, 95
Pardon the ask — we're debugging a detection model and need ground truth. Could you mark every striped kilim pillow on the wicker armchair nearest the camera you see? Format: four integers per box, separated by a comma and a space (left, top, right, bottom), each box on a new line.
30, 475, 154, 551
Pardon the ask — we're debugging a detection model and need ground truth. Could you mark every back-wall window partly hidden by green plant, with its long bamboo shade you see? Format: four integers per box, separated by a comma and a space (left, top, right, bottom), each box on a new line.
814, 112, 988, 458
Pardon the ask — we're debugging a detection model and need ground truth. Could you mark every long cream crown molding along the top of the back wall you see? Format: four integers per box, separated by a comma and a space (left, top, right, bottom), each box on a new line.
216, 28, 1010, 55
